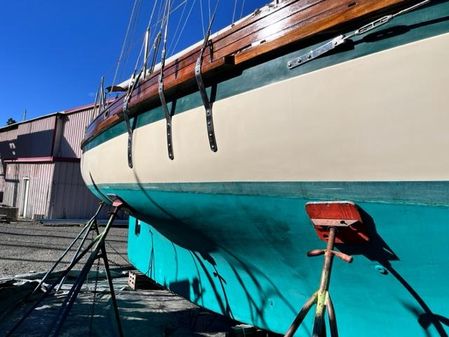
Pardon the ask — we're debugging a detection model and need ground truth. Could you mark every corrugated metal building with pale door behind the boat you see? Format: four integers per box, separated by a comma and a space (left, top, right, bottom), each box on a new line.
0, 105, 105, 219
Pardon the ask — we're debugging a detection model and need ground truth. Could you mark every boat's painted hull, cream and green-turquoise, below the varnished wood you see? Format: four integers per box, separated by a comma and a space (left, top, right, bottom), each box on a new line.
82, 2, 449, 336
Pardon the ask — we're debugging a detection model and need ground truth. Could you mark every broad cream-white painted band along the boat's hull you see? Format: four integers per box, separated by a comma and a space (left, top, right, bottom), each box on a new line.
82, 34, 449, 184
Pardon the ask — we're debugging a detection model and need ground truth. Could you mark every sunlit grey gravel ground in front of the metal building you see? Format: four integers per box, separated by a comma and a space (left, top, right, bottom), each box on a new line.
0, 222, 129, 278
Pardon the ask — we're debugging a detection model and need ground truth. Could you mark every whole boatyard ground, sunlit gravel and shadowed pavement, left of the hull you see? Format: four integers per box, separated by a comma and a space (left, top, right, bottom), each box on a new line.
0, 222, 234, 337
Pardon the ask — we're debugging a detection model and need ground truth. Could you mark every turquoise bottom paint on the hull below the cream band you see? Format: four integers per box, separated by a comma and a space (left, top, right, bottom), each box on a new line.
112, 182, 449, 337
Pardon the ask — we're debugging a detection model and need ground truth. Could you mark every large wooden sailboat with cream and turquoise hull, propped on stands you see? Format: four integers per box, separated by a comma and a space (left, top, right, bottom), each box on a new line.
81, 0, 449, 337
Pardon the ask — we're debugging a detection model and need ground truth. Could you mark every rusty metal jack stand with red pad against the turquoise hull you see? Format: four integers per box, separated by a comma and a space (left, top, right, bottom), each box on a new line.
285, 201, 369, 337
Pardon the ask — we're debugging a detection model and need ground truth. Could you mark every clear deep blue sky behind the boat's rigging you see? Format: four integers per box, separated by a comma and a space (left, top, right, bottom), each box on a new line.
0, 0, 269, 126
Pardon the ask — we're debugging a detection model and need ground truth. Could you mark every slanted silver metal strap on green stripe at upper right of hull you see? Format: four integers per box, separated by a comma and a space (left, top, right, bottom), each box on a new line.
287, 0, 431, 69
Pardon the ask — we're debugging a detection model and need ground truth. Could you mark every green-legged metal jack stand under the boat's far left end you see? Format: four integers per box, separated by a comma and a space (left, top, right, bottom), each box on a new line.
6, 200, 124, 337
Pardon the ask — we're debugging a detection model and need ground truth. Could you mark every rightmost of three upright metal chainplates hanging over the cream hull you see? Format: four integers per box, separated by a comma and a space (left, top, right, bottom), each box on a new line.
195, 1, 219, 152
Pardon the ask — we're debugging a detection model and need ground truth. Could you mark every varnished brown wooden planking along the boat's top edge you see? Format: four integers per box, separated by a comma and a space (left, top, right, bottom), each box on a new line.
83, 0, 417, 144
